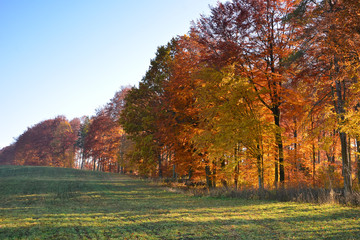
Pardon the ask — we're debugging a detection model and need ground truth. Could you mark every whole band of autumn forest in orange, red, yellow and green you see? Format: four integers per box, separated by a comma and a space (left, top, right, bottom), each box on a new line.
0, 0, 360, 198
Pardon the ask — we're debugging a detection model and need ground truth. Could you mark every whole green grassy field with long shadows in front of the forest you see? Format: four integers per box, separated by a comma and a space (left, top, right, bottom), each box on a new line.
0, 166, 360, 239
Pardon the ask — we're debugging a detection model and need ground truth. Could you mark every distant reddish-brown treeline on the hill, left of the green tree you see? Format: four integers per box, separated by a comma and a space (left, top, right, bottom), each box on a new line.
0, 88, 136, 173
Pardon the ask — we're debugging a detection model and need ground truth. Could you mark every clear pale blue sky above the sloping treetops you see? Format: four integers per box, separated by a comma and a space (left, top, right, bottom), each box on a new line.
0, 0, 222, 149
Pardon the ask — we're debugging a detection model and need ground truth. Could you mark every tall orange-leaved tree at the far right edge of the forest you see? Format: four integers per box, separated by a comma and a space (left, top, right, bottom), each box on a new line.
294, 0, 360, 194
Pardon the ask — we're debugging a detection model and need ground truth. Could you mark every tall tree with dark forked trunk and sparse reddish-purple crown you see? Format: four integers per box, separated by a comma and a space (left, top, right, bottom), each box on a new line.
192, 0, 294, 188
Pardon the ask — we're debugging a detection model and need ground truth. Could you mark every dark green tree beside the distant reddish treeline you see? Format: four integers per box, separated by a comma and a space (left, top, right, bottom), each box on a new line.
120, 40, 175, 177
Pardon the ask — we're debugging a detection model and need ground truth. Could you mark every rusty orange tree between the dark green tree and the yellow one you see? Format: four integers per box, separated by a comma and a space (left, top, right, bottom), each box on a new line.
159, 35, 213, 182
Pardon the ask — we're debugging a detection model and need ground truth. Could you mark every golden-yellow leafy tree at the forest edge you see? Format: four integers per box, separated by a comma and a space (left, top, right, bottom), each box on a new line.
194, 66, 272, 189
